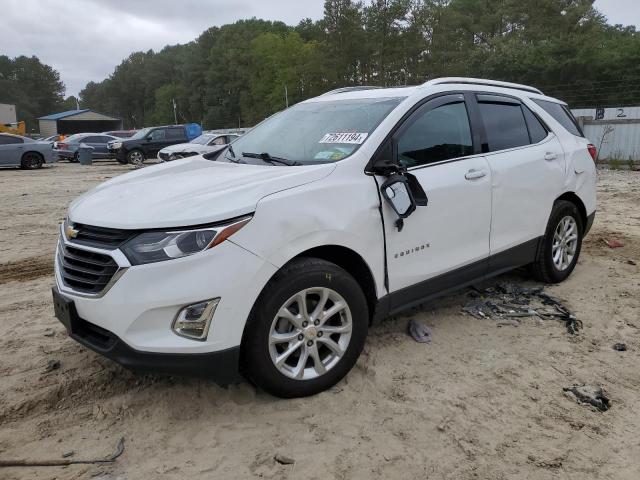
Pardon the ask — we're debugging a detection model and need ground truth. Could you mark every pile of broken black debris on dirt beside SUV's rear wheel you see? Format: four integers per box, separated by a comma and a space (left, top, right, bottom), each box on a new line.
462, 283, 582, 335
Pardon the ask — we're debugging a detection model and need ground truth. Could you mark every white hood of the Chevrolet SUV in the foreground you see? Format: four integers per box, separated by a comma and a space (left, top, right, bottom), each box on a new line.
69, 157, 335, 229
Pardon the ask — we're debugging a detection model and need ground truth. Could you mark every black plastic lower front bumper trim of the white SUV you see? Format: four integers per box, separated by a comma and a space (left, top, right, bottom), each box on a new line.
53, 287, 240, 385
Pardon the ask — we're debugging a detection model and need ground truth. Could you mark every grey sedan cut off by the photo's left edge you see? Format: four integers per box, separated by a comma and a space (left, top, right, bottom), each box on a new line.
0, 133, 55, 169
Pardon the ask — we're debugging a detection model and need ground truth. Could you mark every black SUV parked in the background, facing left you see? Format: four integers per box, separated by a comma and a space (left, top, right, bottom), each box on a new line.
109, 123, 202, 165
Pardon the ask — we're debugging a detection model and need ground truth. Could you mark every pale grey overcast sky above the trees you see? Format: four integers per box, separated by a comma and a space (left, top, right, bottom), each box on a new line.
0, 0, 640, 95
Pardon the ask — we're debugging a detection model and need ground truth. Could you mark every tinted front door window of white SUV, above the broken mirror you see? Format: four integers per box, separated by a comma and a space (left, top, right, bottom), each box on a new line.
398, 102, 473, 167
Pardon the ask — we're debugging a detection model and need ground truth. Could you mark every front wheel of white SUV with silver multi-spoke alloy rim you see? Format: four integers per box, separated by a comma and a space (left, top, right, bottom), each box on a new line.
241, 258, 369, 398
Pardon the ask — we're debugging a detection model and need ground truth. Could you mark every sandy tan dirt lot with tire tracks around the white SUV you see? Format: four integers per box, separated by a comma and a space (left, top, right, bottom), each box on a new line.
0, 163, 640, 480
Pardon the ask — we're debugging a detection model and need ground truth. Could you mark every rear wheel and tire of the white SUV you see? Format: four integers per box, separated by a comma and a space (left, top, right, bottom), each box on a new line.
531, 200, 584, 283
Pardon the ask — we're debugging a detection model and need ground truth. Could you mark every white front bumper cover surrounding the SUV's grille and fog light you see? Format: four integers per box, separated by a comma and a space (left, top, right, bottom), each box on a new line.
55, 225, 276, 377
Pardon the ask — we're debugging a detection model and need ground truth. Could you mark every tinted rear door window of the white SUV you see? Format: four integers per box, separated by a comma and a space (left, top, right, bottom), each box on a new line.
478, 102, 529, 152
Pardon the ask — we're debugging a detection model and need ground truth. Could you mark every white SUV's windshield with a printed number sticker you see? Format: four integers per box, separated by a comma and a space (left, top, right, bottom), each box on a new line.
225, 97, 404, 165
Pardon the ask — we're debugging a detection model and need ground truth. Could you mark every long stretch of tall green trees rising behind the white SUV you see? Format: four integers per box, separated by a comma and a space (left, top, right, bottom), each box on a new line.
0, 0, 640, 128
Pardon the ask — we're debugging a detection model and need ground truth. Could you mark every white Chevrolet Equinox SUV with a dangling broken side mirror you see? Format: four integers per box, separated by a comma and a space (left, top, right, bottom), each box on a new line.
54, 78, 596, 397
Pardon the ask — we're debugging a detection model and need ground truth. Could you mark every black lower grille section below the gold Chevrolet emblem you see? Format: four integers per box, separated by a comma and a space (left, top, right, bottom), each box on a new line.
58, 242, 119, 294
